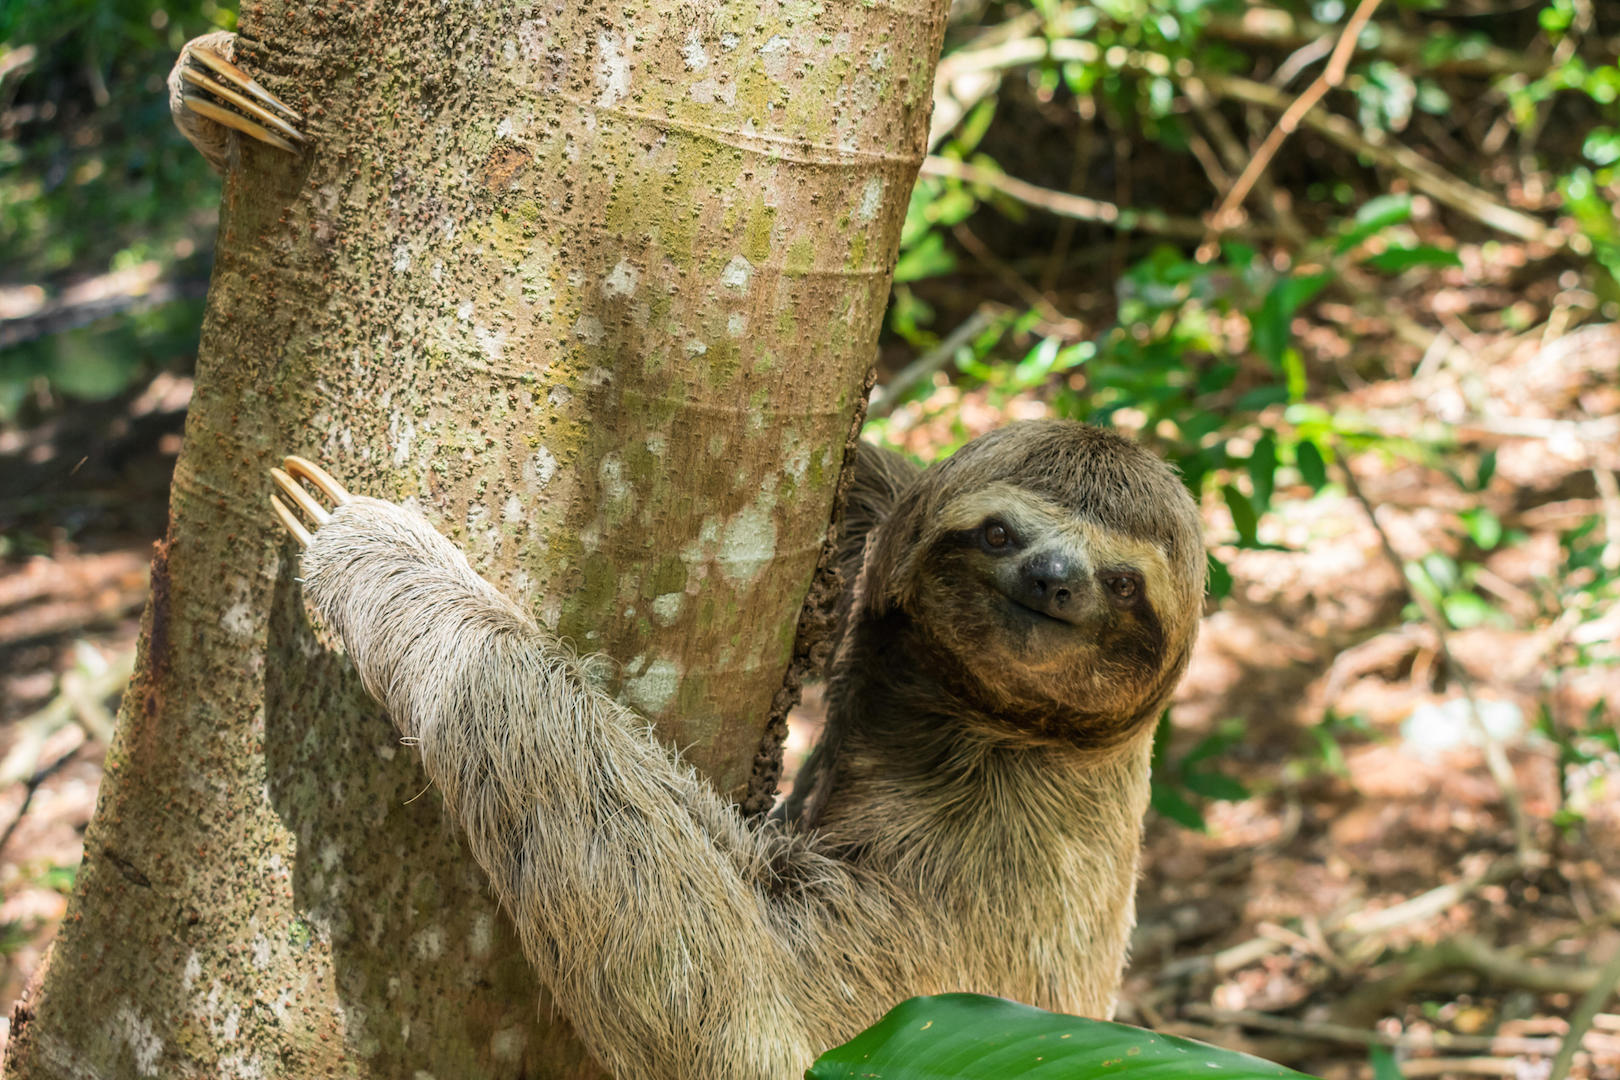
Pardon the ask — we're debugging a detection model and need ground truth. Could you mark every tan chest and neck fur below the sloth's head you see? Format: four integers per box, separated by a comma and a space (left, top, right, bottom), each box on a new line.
821, 725, 1149, 1017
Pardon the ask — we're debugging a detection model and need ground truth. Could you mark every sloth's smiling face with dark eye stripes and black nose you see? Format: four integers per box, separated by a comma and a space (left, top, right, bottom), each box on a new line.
912, 483, 1189, 743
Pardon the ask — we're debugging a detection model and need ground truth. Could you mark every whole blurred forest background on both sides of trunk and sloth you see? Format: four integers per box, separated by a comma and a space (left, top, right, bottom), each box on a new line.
0, 0, 1620, 1080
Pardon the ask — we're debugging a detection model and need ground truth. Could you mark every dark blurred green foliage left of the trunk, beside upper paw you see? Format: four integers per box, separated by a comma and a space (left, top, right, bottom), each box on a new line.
0, 0, 235, 421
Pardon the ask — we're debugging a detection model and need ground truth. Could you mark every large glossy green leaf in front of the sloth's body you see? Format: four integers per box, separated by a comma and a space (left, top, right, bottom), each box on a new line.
805, 994, 1304, 1080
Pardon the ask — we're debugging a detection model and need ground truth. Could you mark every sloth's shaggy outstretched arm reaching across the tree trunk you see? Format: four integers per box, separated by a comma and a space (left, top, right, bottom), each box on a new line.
277, 463, 912, 1077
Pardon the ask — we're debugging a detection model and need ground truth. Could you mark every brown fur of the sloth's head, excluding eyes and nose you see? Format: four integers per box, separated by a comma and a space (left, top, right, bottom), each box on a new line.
857, 421, 1205, 748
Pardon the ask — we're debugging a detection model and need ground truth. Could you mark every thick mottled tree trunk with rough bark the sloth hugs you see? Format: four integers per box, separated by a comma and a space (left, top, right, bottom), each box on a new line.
6, 0, 946, 1080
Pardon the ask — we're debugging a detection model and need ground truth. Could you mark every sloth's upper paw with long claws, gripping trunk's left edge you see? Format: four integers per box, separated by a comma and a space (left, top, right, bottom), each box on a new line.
168, 31, 308, 173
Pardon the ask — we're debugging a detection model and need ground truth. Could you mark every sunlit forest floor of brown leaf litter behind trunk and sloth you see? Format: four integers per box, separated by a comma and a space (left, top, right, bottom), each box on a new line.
0, 325, 1620, 1080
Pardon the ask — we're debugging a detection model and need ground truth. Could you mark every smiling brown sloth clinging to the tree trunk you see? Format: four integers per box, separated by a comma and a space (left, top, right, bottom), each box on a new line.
272, 421, 1205, 1080
